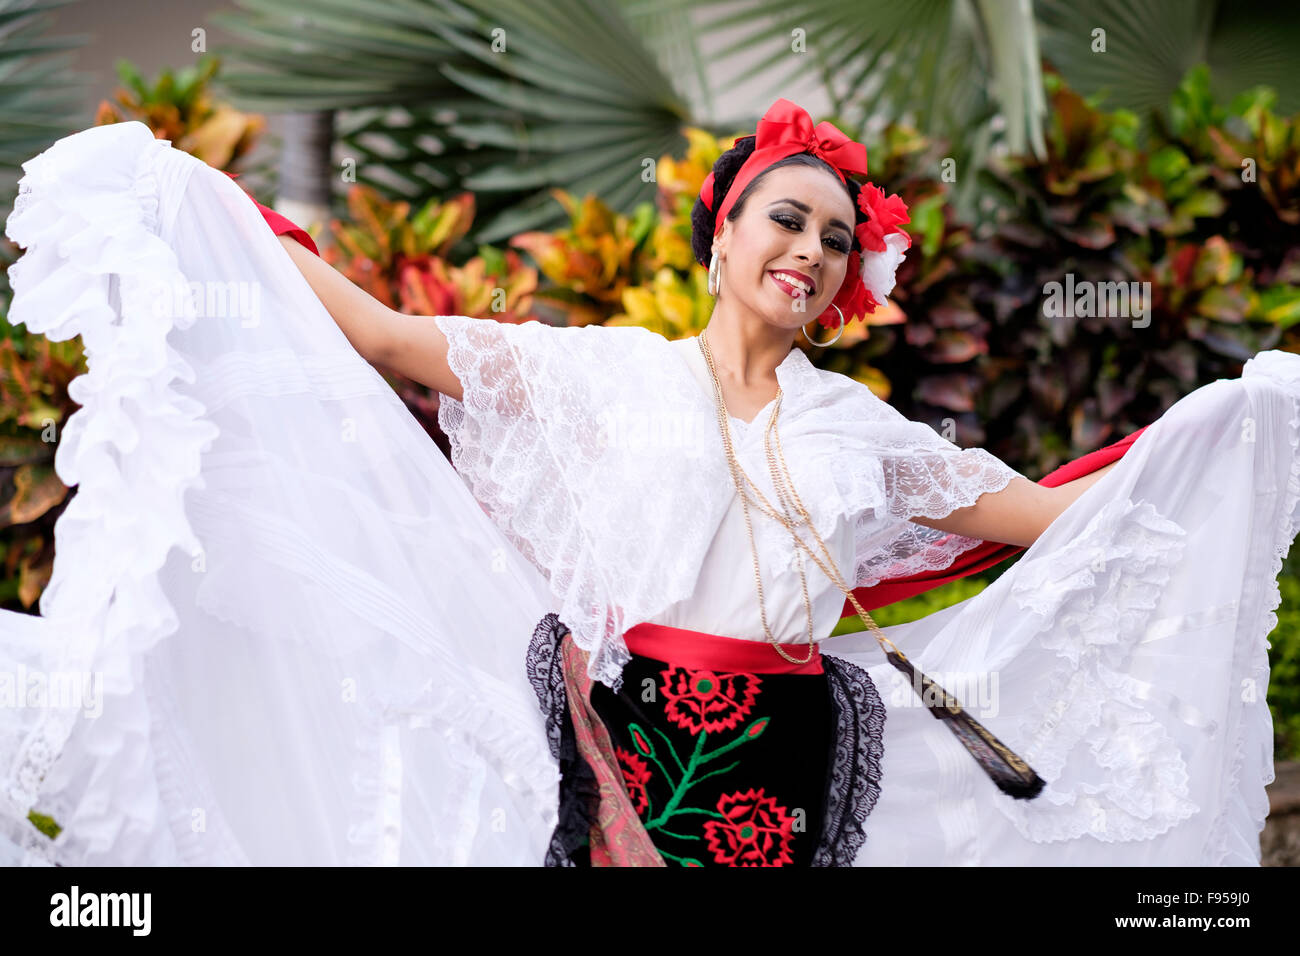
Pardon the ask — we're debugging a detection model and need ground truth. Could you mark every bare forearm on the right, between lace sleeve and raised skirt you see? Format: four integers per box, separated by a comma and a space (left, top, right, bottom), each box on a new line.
911, 460, 1119, 548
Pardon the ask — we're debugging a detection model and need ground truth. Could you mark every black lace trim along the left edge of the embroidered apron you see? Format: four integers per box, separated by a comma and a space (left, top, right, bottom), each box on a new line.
527, 613, 601, 866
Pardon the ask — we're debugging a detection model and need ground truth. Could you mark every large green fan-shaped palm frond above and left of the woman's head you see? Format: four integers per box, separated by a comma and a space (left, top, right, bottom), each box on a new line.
213, 0, 701, 242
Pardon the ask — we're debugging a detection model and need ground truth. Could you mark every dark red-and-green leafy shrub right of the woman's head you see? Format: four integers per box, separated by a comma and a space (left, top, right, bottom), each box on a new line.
857, 68, 1300, 476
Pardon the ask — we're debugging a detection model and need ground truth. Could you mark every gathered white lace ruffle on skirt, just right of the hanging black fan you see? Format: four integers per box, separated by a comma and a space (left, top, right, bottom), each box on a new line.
998, 498, 1197, 843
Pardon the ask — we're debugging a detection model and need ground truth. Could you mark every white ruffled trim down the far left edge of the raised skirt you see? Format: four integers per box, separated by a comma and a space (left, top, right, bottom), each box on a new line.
3, 122, 216, 855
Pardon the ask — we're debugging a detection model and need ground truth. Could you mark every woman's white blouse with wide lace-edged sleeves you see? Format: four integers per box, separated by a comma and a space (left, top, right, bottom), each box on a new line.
434, 316, 1018, 685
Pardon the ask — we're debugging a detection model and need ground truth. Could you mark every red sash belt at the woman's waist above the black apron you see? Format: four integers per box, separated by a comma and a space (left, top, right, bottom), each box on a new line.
623, 622, 823, 674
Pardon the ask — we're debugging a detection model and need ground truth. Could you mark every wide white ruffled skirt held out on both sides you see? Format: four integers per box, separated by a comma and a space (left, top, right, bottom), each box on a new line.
0, 122, 1284, 866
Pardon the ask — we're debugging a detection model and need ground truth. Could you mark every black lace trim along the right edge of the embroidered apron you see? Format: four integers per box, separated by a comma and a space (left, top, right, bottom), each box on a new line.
813, 654, 885, 866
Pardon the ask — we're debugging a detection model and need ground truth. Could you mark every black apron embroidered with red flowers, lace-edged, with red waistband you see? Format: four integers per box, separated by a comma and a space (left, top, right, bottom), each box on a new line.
528, 614, 884, 866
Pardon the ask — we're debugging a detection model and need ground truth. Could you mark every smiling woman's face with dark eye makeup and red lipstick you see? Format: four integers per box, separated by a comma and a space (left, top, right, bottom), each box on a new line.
714, 165, 854, 332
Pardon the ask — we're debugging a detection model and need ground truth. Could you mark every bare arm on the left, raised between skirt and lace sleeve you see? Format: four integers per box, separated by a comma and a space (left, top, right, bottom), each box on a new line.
280, 235, 464, 401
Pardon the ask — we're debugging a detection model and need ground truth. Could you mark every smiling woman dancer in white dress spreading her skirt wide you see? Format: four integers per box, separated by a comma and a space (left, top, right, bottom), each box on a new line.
3, 100, 1284, 865
